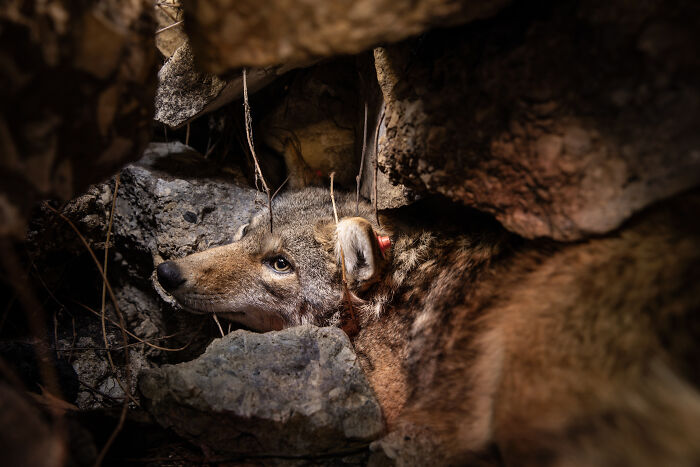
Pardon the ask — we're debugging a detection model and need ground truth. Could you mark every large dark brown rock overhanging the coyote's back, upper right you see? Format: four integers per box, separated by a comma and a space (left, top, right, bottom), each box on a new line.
375, 0, 700, 240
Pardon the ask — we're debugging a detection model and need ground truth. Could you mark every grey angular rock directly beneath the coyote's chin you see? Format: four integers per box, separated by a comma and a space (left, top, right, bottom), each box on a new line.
139, 326, 384, 457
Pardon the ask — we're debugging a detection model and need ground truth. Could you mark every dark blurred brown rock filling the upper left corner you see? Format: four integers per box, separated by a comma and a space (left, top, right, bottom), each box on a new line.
0, 0, 157, 239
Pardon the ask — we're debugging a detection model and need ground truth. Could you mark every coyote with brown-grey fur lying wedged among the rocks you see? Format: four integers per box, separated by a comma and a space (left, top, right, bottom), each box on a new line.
157, 188, 700, 466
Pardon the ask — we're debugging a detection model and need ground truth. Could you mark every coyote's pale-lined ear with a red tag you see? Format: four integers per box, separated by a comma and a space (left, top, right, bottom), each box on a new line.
335, 217, 390, 289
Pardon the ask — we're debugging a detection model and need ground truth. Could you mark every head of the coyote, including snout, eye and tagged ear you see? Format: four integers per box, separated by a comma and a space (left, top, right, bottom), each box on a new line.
157, 189, 390, 331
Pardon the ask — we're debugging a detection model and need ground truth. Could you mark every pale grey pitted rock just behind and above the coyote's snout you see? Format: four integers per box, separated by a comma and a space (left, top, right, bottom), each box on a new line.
114, 142, 258, 268
